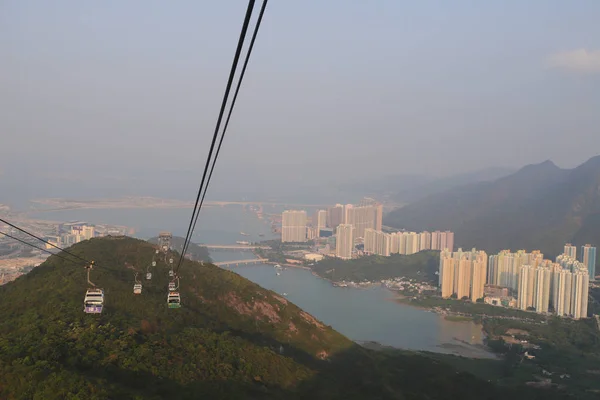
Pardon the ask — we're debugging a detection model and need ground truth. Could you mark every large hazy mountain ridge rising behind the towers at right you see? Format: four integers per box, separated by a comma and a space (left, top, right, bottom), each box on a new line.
384, 156, 600, 257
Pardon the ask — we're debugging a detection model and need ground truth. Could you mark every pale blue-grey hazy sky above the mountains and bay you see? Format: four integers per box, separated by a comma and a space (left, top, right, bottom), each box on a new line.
0, 0, 600, 193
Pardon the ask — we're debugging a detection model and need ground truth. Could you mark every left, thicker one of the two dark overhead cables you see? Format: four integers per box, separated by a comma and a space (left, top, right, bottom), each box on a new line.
175, 0, 255, 270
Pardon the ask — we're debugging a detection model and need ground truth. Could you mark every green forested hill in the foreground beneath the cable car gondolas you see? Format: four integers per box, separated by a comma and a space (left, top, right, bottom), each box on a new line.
0, 237, 568, 400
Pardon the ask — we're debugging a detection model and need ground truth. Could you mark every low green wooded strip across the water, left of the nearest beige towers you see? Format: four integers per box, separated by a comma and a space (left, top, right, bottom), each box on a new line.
312, 251, 440, 284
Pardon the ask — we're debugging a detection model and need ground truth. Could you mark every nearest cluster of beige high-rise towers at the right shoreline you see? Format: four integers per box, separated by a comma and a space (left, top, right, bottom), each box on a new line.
439, 244, 596, 319
